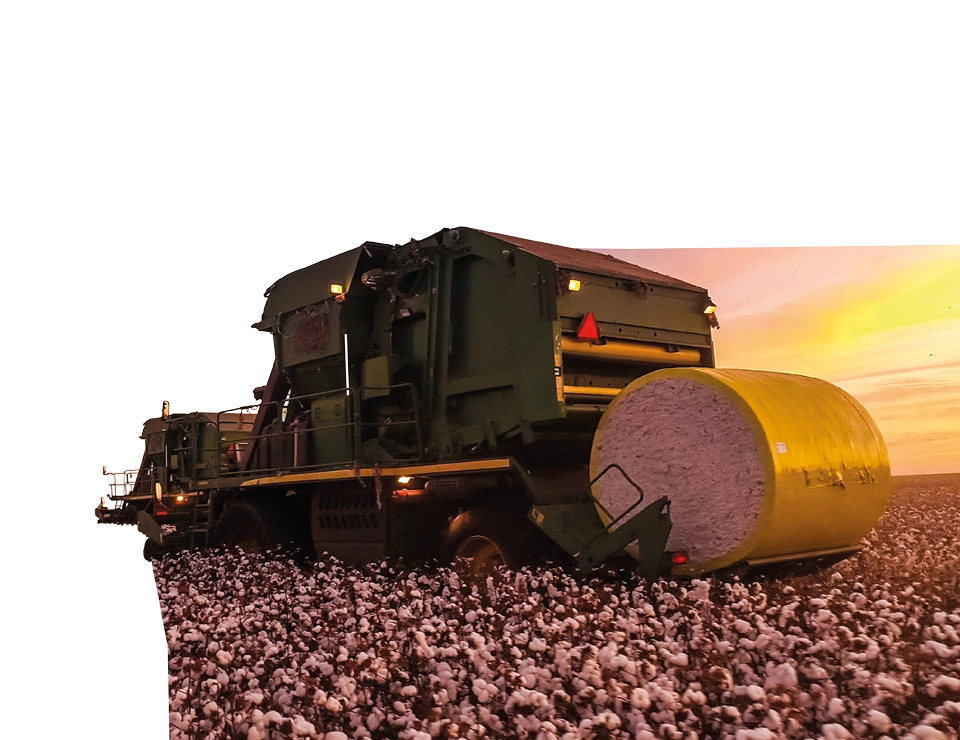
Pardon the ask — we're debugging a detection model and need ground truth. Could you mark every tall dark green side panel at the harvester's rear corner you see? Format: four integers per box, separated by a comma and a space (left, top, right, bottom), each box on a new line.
416, 232, 563, 459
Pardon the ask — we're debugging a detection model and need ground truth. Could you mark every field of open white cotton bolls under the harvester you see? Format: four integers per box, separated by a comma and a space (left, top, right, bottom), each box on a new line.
153, 476, 960, 740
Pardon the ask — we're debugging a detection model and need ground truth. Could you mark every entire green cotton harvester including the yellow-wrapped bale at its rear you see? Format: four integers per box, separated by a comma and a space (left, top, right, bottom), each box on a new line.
96, 227, 890, 575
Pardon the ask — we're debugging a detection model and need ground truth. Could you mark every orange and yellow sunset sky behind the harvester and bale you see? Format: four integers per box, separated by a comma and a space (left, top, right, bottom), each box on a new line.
610, 244, 960, 475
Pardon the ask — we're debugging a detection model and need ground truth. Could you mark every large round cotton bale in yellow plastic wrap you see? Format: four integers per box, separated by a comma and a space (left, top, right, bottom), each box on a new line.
591, 368, 890, 574
